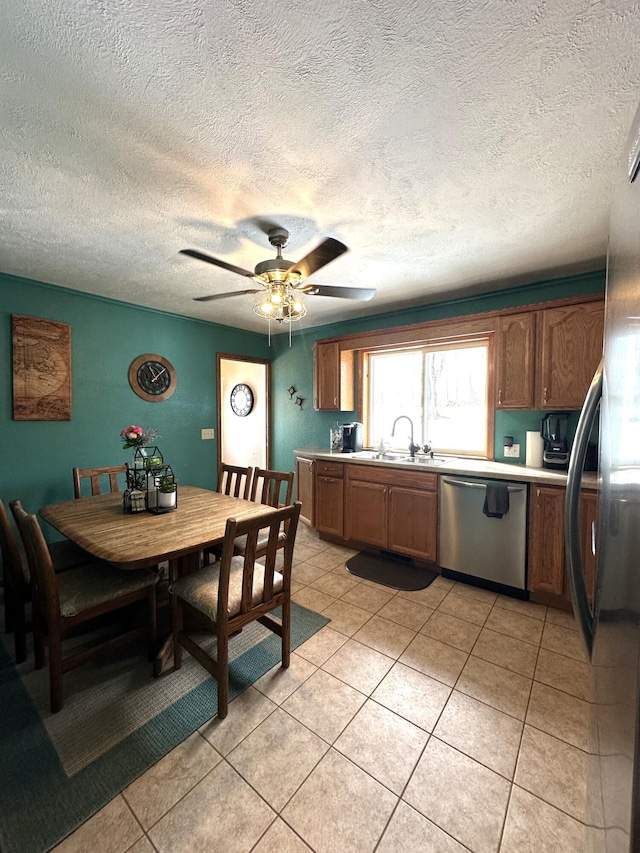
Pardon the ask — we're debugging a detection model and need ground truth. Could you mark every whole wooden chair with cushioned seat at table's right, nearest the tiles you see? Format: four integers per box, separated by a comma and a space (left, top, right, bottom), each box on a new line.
169, 502, 302, 719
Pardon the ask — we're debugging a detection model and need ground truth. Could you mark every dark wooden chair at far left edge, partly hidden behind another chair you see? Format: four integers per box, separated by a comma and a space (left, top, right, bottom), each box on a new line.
0, 500, 94, 663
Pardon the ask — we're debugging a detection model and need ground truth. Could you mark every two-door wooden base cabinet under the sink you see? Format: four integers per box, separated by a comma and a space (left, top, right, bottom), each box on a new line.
344, 465, 438, 562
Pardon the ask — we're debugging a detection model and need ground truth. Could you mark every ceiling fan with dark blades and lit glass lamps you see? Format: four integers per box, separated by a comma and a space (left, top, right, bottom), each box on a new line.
180, 228, 376, 323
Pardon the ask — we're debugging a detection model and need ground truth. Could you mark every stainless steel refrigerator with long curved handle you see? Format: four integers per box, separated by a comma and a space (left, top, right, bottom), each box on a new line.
565, 98, 640, 853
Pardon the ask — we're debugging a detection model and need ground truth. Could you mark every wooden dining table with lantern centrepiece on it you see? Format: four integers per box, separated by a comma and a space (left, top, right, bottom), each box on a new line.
39, 486, 273, 675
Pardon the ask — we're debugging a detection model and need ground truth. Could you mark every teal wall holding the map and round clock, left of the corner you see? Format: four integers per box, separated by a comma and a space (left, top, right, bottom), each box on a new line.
0, 275, 271, 539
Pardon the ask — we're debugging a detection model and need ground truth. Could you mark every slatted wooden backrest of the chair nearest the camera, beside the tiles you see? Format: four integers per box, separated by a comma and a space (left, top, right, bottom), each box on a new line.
216, 501, 302, 627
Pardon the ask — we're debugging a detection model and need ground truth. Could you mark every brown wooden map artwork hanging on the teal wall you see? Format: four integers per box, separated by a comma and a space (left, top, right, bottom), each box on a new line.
11, 314, 71, 421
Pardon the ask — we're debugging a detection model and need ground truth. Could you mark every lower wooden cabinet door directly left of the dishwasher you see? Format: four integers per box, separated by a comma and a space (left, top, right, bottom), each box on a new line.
387, 486, 438, 563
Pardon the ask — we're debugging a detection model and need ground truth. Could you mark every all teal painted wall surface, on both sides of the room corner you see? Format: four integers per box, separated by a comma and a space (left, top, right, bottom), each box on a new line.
0, 271, 605, 538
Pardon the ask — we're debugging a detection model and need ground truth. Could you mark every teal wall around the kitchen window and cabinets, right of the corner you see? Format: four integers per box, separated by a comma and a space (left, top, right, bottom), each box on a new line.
272, 270, 605, 470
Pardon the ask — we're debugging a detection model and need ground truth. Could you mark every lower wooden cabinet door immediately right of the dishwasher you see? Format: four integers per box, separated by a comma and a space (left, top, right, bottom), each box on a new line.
528, 486, 564, 595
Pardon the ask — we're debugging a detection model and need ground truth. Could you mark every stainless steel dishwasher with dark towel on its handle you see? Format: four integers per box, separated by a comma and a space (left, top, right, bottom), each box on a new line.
438, 474, 529, 597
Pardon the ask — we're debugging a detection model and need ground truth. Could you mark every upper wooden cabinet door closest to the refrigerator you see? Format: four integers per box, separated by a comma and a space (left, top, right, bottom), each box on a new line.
539, 302, 604, 409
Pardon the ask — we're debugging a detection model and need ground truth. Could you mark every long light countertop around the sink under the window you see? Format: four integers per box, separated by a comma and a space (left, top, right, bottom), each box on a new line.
293, 447, 597, 489
